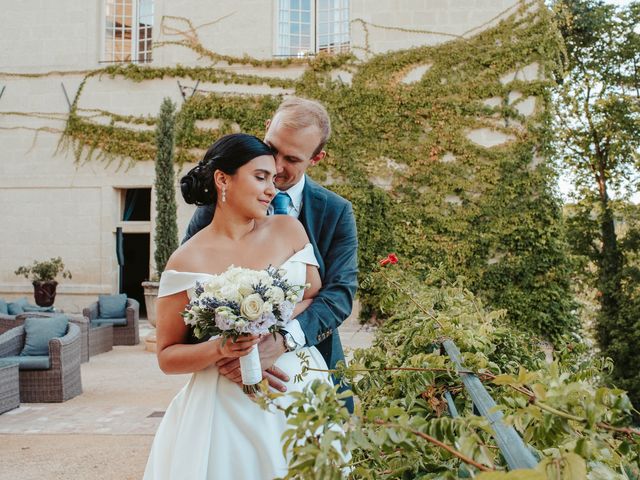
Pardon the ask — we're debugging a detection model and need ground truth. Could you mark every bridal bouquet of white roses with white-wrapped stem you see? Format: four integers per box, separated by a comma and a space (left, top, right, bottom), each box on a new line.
182, 265, 305, 393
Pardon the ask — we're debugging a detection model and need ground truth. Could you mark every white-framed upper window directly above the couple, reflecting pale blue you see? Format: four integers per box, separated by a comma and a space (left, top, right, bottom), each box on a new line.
276, 0, 349, 57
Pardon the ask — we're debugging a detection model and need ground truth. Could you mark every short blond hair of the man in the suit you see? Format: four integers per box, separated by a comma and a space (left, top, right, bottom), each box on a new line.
273, 97, 331, 157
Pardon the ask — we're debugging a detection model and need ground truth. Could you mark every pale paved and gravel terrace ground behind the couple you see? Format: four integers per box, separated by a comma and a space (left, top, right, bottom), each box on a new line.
0, 312, 373, 480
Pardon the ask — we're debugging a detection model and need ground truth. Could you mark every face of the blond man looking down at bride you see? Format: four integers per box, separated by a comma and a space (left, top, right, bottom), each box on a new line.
264, 113, 325, 191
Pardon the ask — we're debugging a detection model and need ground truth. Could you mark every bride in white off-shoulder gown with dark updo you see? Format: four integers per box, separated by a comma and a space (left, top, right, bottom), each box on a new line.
144, 134, 331, 480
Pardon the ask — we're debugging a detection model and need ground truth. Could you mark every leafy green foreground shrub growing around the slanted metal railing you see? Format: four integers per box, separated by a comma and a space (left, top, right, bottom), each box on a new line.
263, 262, 640, 480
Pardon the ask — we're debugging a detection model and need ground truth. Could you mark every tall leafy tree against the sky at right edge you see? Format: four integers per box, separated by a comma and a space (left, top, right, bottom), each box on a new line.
554, 0, 640, 402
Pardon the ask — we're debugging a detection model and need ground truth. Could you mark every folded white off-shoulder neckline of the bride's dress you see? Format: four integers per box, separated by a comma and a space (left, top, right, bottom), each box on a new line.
158, 243, 318, 298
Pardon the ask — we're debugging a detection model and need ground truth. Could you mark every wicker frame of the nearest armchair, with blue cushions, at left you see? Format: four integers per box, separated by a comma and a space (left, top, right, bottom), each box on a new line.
0, 322, 82, 403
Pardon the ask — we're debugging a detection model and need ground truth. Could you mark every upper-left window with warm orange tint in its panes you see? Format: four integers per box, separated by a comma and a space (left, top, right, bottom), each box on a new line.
104, 0, 153, 63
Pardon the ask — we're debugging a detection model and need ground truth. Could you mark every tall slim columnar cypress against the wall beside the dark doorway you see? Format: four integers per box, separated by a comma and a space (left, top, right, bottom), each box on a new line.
154, 98, 178, 274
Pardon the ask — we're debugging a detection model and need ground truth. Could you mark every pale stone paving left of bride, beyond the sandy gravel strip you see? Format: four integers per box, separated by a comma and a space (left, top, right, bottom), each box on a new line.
0, 322, 188, 435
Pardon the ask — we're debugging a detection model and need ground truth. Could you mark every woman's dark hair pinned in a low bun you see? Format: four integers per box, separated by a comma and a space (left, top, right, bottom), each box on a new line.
180, 133, 273, 205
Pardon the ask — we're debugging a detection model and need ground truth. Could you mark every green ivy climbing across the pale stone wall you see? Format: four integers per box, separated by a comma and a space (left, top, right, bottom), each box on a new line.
64, 2, 576, 338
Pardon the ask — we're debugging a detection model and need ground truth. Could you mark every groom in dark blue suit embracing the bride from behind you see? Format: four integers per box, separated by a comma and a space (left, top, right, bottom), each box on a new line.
183, 98, 358, 411
